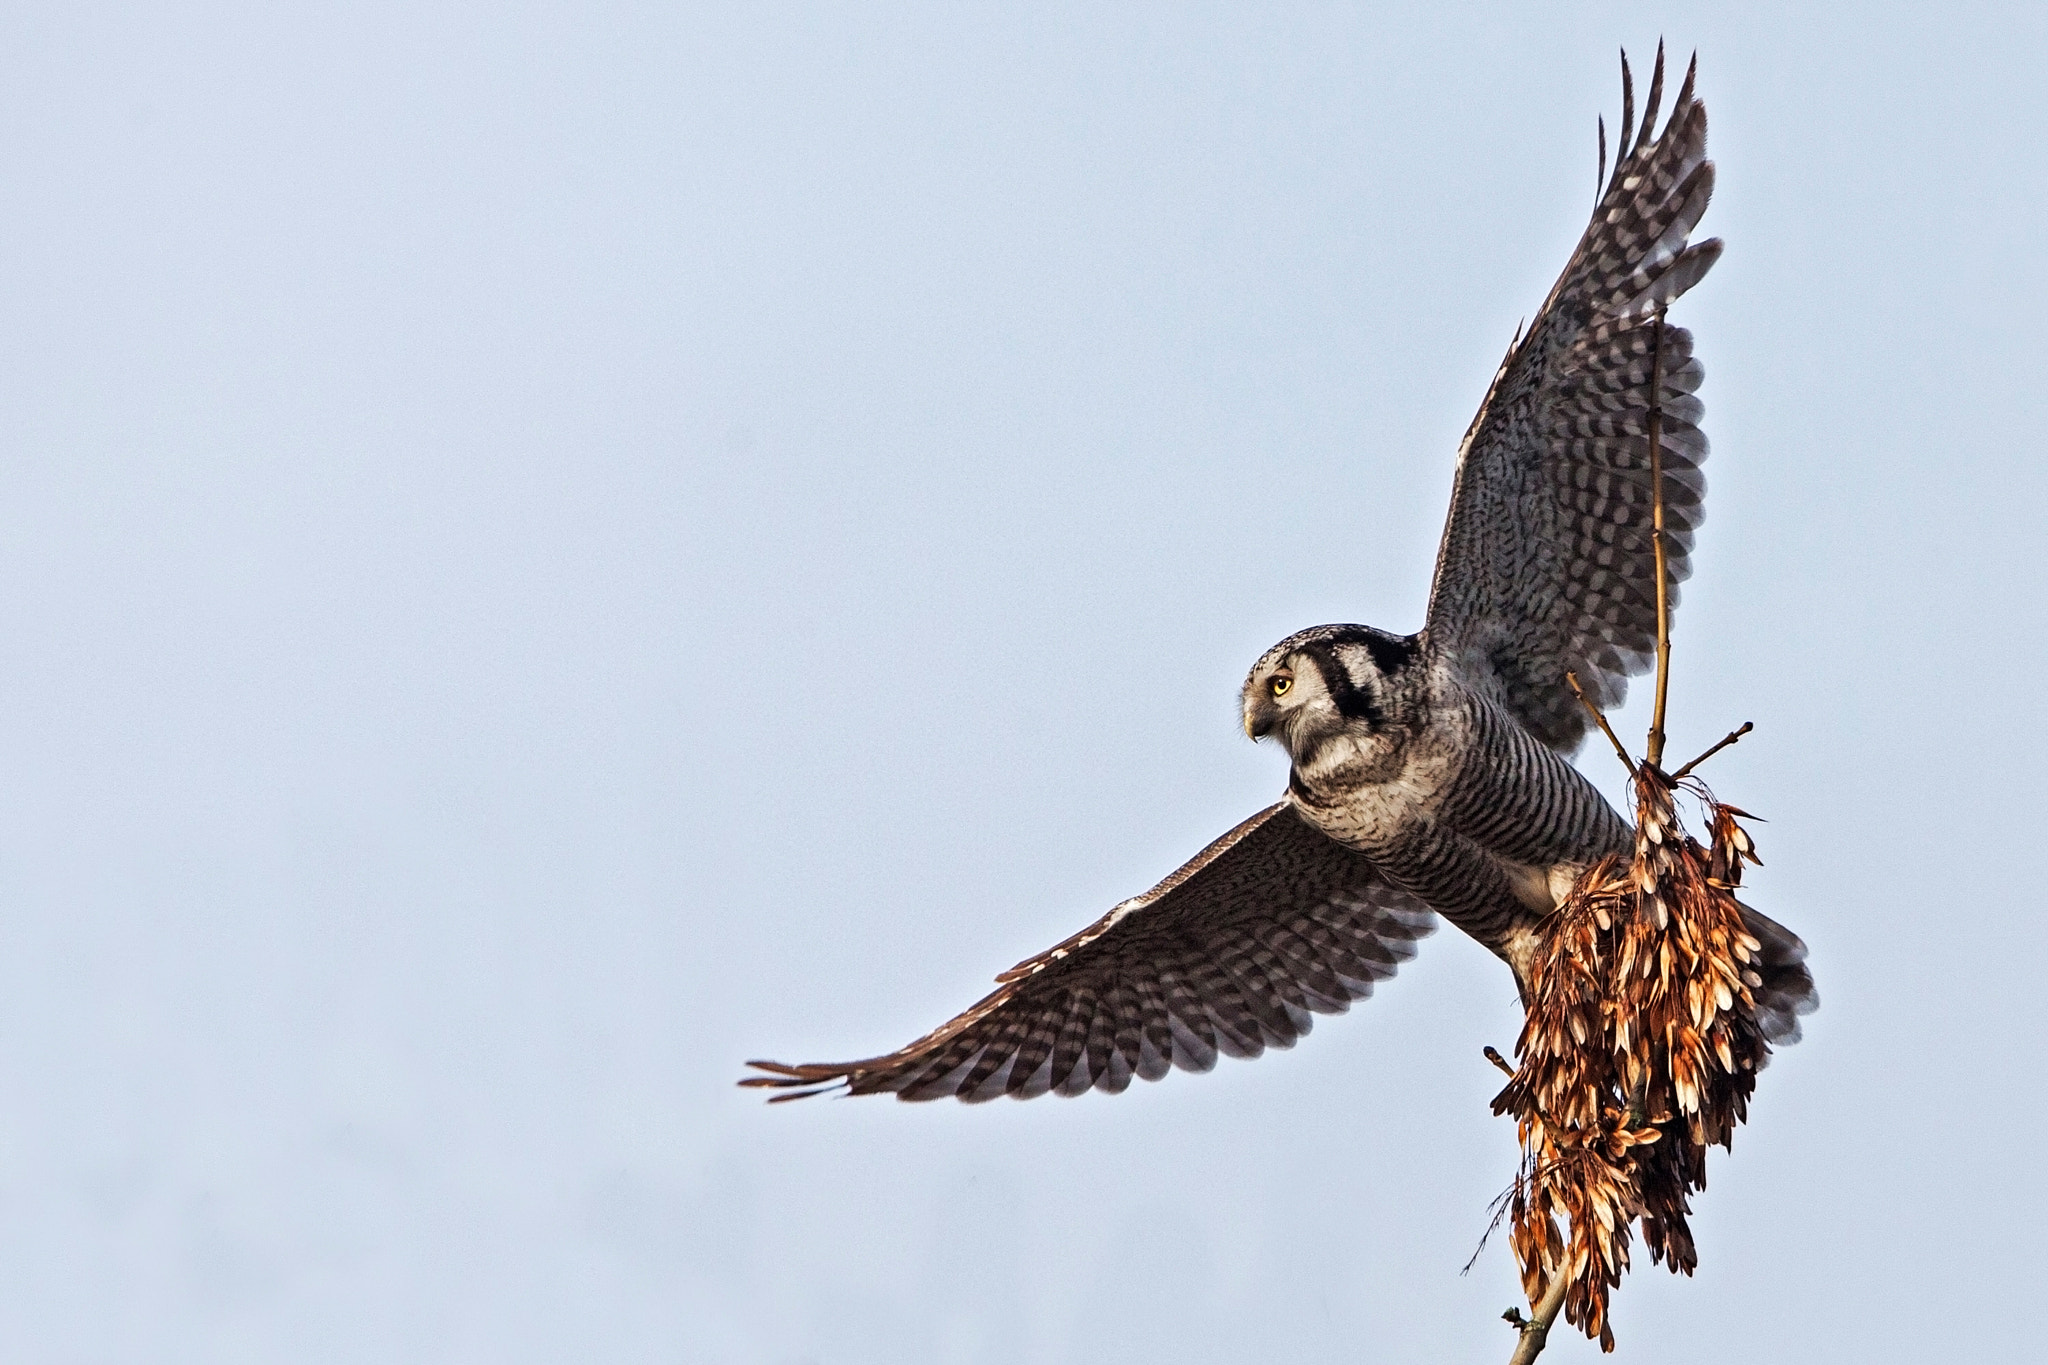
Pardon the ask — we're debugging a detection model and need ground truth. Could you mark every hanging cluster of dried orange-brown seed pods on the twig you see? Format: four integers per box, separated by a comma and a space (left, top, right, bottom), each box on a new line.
1493, 763, 1769, 1351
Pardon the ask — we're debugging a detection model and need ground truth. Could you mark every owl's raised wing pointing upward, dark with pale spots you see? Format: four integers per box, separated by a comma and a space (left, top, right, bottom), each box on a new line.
1423, 49, 1720, 753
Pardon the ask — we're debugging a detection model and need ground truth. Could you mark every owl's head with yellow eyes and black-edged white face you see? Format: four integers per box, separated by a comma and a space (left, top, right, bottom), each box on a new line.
1239, 626, 1415, 763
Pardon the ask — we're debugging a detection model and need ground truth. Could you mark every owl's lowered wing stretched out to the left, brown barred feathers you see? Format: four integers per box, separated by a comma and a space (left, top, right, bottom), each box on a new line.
739, 802, 1434, 1101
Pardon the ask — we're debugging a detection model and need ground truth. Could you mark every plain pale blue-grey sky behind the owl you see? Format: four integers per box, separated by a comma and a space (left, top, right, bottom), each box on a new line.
0, 0, 2048, 1365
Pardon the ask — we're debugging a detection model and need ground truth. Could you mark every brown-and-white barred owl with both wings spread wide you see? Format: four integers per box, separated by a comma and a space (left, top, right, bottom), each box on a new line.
741, 53, 1817, 1101
